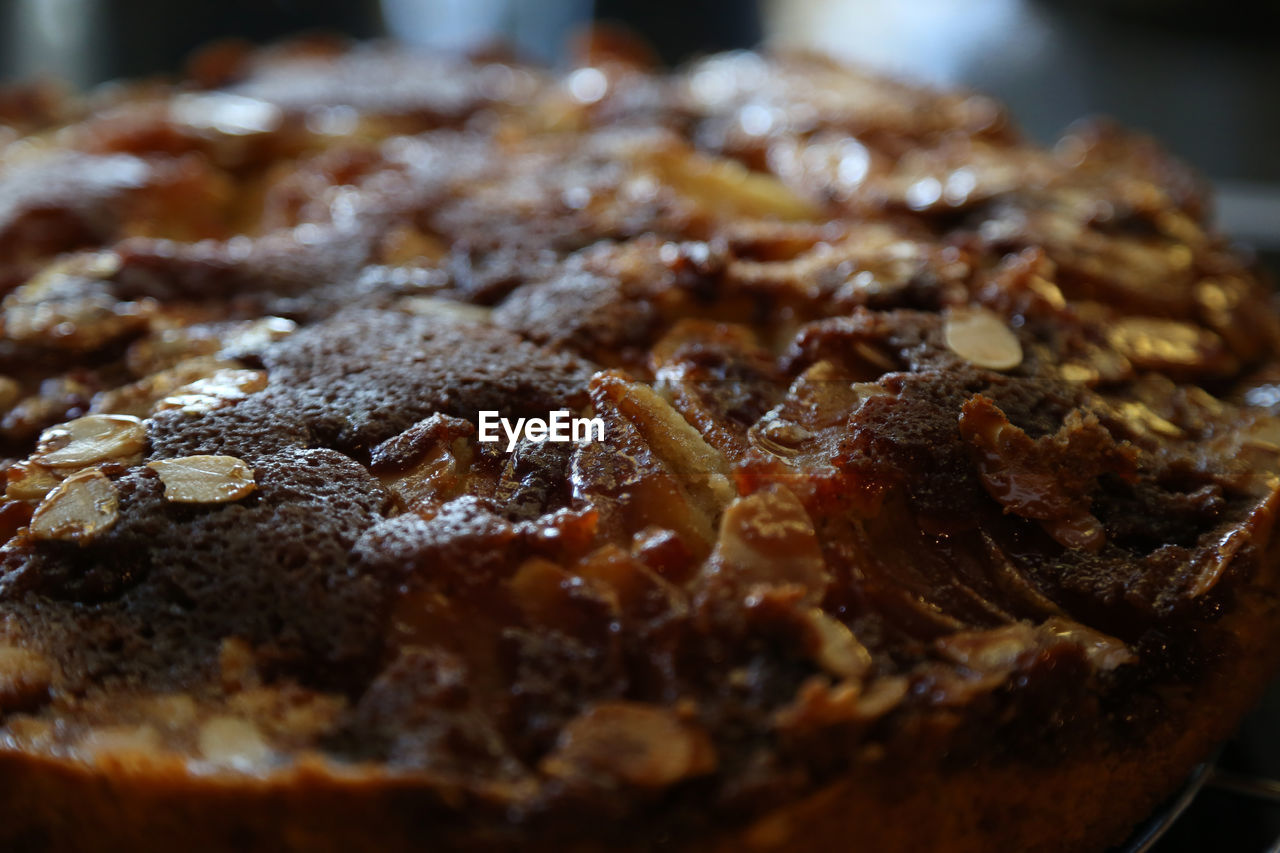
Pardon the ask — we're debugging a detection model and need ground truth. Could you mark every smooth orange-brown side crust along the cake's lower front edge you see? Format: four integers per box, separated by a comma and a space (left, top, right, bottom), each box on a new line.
0, 584, 1280, 853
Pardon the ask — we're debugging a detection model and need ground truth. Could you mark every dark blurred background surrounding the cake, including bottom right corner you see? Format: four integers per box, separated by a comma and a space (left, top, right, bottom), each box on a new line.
0, 0, 1280, 853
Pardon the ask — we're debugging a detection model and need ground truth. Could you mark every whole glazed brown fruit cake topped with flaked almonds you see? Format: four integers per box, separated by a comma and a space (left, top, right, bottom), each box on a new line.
0, 41, 1280, 852
